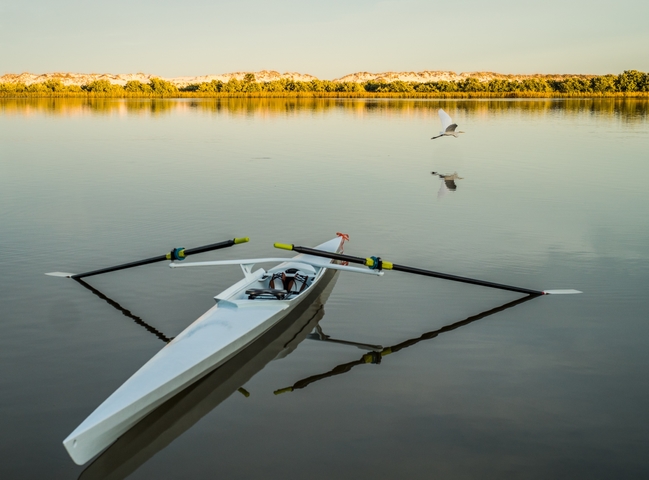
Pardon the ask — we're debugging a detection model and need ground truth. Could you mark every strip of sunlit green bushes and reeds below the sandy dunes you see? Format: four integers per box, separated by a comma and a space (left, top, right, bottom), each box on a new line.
0, 70, 649, 97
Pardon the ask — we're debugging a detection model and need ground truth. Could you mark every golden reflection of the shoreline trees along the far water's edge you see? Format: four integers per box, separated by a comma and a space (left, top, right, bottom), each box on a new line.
0, 97, 649, 122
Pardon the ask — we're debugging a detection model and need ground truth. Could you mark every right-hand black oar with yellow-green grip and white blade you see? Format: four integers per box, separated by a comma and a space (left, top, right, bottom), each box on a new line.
275, 243, 581, 295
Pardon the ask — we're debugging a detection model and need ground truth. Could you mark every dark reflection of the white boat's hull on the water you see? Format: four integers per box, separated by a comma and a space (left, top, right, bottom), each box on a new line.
80, 270, 336, 480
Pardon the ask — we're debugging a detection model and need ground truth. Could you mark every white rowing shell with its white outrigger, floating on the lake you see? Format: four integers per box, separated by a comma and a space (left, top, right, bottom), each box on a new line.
63, 238, 380, 464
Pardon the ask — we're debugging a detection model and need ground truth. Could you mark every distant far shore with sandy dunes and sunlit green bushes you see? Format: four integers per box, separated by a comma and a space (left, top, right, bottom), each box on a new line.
0, 70, 649, 98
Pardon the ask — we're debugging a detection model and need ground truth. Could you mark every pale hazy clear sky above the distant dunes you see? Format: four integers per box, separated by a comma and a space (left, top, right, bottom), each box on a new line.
0, 0, 649, 80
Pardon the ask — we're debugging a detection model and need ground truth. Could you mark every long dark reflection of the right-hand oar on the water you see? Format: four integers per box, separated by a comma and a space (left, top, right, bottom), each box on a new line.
274, 295, 536, 395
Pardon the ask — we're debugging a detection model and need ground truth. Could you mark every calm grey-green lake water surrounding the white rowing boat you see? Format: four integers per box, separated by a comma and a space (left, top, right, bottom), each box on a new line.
0, 99, 649, 479
